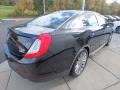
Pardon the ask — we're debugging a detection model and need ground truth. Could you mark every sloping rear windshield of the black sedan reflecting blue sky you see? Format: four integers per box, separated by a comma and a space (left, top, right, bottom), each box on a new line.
28, 12, 75, 29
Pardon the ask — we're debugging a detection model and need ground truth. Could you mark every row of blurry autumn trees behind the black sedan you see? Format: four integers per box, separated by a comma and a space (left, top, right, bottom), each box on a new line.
7, 0, 120, 16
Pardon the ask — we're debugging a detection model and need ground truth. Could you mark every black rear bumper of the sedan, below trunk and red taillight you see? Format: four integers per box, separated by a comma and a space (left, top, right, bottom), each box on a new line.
5, 44, 73, 82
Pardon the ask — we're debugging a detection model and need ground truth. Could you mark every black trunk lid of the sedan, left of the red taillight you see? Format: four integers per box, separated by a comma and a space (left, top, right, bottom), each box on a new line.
7, 27, 53, 60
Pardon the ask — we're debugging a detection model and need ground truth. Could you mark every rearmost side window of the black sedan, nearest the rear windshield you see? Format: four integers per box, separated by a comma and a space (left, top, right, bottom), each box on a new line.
62, 16, 89, 29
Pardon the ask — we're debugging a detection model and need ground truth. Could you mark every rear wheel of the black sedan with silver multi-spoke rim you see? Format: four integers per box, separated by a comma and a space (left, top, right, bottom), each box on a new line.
70, 49, 88, 77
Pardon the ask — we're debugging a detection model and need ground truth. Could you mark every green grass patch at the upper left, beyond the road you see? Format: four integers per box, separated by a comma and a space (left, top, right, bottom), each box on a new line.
0, 5, 14, 20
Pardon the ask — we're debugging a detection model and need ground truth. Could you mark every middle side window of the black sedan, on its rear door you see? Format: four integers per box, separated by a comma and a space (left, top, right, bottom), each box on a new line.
86, 14, 98, 26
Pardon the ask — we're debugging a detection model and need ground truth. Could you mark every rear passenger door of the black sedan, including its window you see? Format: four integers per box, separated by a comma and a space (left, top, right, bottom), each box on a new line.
86, 13, 101, 52
